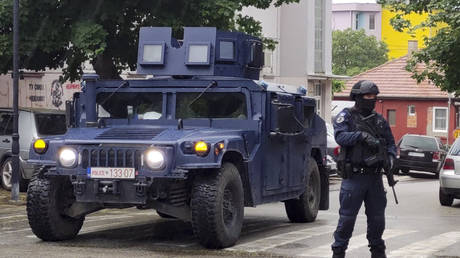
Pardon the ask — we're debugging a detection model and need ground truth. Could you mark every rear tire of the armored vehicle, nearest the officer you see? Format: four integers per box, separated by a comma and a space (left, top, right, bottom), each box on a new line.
284, 157, 321, 223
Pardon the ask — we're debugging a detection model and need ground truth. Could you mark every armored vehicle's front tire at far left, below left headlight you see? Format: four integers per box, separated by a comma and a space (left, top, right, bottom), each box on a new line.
27, 174, 85, 241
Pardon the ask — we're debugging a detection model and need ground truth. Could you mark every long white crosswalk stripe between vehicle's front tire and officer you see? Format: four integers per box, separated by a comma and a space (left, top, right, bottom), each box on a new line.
226, 226, 335, 252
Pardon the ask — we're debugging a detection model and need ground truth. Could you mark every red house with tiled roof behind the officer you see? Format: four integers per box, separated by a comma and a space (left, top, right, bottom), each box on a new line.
334, 56, 460, 144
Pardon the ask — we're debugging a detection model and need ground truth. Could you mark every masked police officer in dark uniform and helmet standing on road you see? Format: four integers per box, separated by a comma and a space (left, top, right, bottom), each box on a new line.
332, 81, 396, 258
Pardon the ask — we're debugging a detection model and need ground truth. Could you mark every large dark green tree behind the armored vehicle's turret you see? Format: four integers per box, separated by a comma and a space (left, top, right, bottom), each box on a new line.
0, 0, 298, 81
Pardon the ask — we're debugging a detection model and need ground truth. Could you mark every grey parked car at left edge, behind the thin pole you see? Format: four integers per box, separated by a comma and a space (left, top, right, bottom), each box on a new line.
0, 108, 67, 191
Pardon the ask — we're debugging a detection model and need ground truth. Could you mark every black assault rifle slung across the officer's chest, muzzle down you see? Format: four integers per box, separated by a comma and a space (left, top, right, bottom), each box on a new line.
357, 113, 399, 204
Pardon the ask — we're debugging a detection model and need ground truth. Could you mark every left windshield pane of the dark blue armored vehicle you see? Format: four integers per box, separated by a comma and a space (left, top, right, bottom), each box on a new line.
96, 92, 163, 120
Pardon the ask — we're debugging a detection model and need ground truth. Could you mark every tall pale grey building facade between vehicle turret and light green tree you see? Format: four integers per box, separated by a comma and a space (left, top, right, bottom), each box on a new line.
242, 0, 334, 121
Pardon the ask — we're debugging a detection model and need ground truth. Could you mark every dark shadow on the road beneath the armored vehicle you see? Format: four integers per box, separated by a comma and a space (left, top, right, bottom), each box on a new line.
37, 213, 320, 253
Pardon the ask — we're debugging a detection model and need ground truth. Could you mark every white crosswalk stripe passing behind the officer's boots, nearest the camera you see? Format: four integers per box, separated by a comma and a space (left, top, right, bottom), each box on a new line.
297, 229, 416, 257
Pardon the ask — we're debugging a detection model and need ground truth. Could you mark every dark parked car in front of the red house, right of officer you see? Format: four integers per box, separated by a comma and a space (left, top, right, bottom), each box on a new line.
396, 134, 446, 174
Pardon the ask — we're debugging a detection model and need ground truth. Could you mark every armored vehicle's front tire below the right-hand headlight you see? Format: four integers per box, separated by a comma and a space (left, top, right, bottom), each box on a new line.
191, 163, 244, 249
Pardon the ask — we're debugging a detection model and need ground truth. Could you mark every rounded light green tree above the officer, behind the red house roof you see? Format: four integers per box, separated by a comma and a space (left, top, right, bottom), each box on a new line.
332, 29, 388, 76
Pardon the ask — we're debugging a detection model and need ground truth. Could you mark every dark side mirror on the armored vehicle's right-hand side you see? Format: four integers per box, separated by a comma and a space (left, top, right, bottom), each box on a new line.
270, 100, 304, 134
